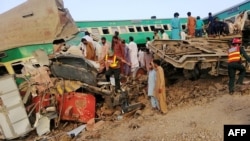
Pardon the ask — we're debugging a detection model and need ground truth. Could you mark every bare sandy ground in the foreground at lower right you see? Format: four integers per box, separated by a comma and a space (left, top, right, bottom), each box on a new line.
90, 95, 250, 141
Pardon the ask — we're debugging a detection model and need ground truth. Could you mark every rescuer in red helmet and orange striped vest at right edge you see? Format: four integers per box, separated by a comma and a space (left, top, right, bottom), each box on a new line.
228, 38, 250, 94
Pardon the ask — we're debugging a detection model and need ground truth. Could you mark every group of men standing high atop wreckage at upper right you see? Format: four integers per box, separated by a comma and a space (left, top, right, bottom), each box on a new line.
171, 11, 246, 40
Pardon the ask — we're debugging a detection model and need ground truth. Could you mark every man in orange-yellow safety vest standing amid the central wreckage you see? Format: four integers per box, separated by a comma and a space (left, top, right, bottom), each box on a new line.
105, 49, 130, 92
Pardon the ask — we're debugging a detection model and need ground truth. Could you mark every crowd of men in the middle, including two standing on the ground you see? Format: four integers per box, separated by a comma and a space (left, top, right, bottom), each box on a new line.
54, 30, 169, 114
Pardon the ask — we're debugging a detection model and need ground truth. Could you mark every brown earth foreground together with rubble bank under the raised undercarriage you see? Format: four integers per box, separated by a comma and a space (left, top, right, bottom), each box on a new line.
21, 76, 250, 141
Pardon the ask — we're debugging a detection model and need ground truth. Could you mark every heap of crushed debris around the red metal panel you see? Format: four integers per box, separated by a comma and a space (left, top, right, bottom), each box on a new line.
0, 51, 147, 139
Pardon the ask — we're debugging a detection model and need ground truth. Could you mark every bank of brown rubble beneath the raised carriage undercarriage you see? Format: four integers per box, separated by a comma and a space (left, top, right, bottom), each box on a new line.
167, 77, 227, 109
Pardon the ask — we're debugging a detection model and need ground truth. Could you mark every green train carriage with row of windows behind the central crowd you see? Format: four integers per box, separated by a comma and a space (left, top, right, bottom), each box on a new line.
76, 18, 187, 46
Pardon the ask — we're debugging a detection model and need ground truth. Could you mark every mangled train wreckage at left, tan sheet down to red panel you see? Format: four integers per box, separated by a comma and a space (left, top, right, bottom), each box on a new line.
0, 0, 146, 139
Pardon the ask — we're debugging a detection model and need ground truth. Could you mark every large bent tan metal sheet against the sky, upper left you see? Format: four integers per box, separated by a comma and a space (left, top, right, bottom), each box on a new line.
0, 0, 78, 51
